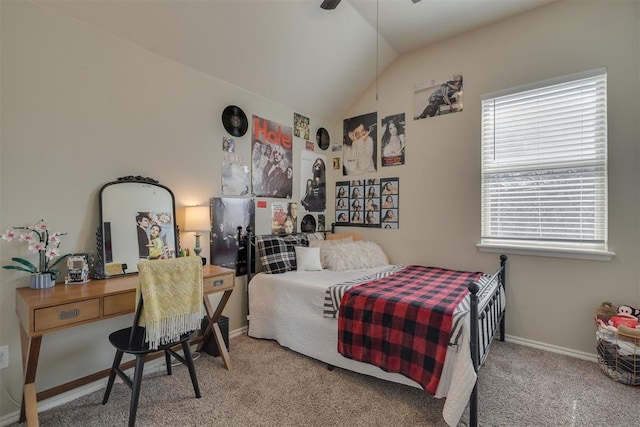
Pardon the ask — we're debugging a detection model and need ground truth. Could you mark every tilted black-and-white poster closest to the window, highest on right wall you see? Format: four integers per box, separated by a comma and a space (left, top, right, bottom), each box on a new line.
413, 74, 462, 120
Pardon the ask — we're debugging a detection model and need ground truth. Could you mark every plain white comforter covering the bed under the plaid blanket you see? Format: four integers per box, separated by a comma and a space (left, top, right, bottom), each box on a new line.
249, 266, 476, 426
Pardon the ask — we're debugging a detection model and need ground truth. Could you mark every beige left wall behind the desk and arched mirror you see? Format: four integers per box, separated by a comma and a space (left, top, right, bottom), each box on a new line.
0, 2, 326, 416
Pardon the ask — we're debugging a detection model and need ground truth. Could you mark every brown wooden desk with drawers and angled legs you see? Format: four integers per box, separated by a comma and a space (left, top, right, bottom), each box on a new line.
16, 265, 235, 426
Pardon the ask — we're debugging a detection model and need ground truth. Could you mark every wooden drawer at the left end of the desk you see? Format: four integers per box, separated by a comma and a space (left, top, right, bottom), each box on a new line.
34, 298, 100, 332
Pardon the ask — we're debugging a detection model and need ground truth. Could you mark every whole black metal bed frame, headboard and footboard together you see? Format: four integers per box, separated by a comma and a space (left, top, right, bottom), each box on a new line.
238, 223, 507, 427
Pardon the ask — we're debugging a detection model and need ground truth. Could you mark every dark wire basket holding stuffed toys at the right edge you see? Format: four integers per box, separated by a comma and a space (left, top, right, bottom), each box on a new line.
595, 314, 640, 385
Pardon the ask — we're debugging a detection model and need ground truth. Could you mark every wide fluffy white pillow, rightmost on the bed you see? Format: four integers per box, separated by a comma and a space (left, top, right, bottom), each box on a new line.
323, 240, 389, 271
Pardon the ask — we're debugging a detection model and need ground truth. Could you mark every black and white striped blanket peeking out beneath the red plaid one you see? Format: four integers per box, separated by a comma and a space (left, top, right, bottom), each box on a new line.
323, 264, 505, 347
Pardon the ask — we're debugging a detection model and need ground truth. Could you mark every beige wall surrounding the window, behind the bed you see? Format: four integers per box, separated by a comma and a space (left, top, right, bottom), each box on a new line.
331, 1, 640, 354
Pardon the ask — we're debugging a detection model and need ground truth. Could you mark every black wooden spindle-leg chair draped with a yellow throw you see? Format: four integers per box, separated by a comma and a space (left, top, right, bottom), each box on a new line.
102, 257, 202, 427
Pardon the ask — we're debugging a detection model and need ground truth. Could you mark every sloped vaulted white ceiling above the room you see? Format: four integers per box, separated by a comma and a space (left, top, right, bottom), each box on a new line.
35, 0, 554, 120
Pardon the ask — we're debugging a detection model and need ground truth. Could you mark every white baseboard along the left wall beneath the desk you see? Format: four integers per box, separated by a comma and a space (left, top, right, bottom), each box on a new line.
0, 326, 247, 426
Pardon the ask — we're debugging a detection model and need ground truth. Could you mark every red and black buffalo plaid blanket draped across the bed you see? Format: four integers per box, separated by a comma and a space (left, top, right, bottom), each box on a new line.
338, 265, 482, 394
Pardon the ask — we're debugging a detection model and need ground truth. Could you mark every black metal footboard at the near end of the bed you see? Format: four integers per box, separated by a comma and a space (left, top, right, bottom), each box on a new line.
469, 255, 507, 427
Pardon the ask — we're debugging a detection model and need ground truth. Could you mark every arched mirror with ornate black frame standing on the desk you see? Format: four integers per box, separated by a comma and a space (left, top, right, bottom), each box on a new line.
94, 176, 179, 278
